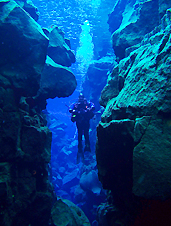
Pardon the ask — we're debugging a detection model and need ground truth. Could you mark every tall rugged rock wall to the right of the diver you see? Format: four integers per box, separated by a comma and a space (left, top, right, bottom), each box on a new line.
96, 1, 171, 225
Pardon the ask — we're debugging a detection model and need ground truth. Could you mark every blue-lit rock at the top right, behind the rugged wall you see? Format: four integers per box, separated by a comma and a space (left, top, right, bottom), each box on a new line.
108, 0, 171, 59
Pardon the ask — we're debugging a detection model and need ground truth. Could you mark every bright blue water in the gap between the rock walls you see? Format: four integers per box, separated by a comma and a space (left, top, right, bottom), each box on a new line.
33, 0, 115, 222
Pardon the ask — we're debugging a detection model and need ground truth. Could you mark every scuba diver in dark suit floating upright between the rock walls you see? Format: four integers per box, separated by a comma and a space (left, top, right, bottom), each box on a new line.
69, 93, 95, 163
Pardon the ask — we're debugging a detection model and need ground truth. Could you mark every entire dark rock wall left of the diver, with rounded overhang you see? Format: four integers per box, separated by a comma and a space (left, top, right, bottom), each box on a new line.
0, 0, 80, 226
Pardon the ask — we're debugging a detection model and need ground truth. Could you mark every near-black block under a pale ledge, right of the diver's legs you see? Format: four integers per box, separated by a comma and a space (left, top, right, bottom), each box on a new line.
96, 119, 134, 198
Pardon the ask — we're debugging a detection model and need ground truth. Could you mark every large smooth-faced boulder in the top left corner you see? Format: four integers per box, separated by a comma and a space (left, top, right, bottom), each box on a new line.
0, 0, 49, 96
